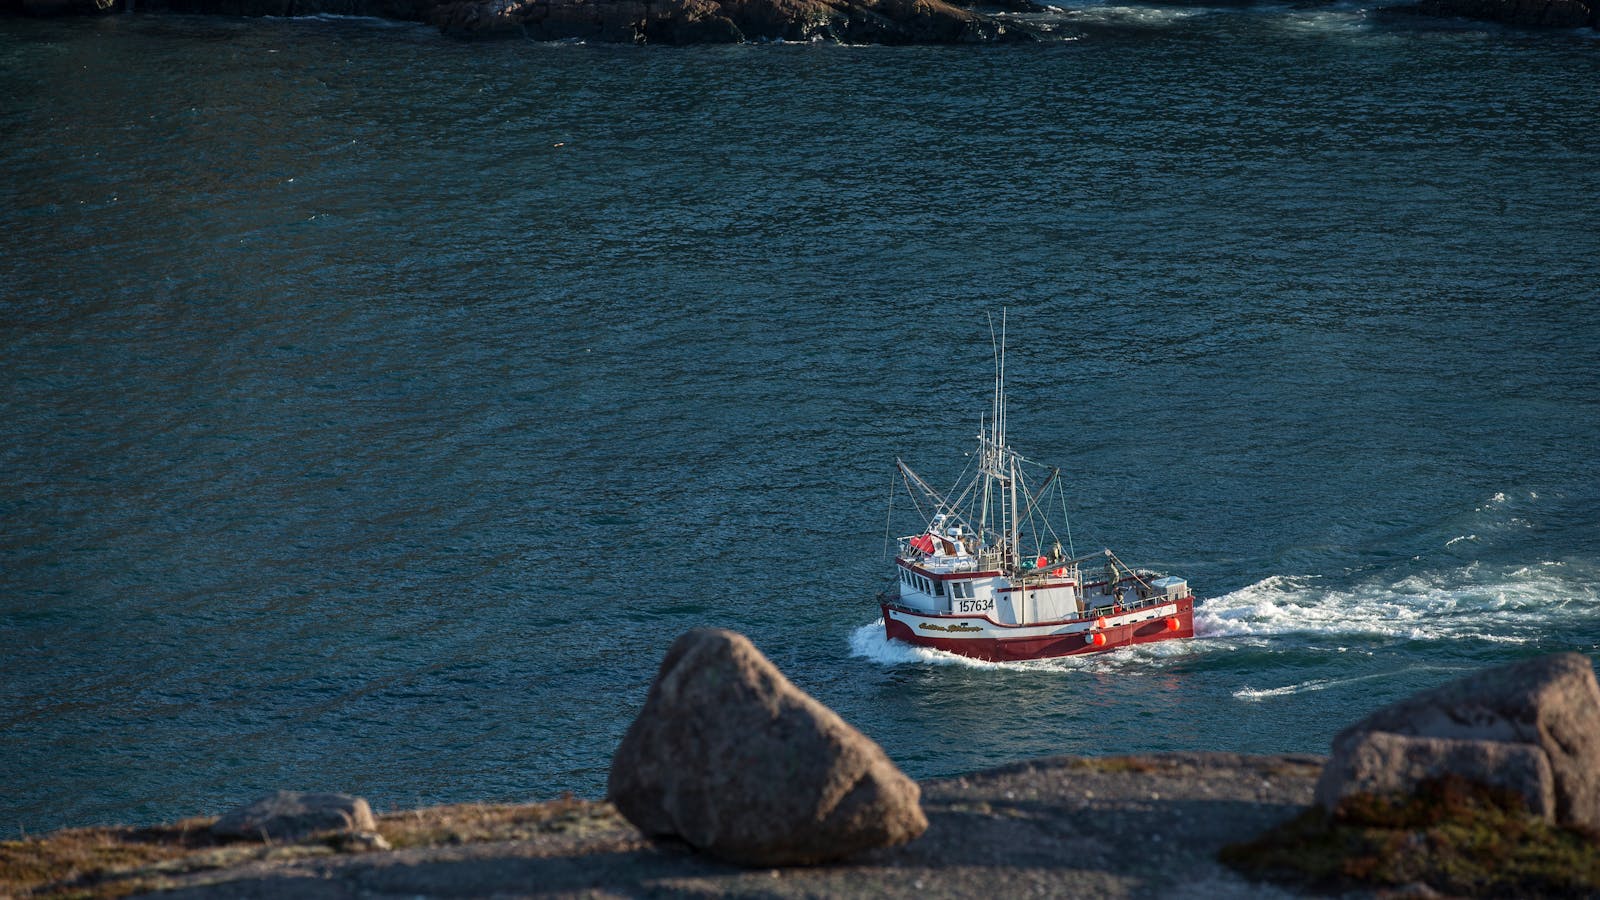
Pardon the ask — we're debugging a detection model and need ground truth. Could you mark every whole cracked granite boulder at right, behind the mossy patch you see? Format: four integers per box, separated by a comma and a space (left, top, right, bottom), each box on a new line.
1317, 643, 1600, 828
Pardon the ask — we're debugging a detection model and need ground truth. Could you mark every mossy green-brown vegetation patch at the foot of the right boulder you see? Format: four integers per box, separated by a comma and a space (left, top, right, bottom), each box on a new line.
1219, 777, 1600, 897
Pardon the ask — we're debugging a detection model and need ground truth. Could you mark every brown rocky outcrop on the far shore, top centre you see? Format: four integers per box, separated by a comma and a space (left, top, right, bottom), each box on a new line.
429, 0, 1030, 43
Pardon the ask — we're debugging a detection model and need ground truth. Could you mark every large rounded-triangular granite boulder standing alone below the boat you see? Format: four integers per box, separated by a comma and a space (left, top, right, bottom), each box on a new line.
606, 629, 928, 866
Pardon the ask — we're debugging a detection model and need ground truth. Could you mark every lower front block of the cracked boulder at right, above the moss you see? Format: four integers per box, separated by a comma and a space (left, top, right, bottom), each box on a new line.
1317, 732, 1555, 822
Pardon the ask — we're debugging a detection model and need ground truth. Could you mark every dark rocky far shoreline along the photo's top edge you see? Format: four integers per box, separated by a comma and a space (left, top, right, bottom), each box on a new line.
0, 0, 1600, 45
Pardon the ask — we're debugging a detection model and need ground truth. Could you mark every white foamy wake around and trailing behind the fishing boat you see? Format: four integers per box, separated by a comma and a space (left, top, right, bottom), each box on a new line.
850, 493, 1600, 666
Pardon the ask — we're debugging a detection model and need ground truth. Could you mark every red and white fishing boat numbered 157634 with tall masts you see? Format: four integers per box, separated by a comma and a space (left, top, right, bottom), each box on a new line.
878, 322, 1195, 661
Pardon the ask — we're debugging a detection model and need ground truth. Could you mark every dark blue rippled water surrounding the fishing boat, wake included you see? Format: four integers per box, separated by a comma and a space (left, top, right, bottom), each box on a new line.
0, 6, 1600, 833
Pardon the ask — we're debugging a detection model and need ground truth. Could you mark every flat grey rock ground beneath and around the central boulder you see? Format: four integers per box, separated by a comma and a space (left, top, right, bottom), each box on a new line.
140, 753, 1323, 900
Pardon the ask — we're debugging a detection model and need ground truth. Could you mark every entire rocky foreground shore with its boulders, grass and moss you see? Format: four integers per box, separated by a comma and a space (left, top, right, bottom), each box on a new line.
0, 640, 1600, 900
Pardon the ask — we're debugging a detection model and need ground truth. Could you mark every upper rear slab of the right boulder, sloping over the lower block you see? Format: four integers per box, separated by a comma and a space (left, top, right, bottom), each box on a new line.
1318, 653, 1600, 828
